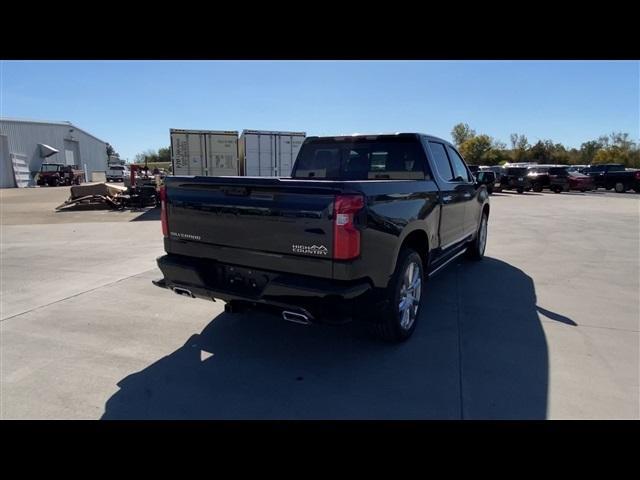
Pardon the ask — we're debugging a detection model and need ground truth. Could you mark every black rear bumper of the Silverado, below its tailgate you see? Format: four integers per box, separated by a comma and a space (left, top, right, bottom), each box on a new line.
154, 254, 372, 323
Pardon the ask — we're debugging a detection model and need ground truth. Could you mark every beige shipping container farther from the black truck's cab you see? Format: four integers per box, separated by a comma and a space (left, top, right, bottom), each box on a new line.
169, 128, 240, 177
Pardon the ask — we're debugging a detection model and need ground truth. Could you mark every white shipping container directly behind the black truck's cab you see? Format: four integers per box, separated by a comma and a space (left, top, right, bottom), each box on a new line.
238, 130, 306, 177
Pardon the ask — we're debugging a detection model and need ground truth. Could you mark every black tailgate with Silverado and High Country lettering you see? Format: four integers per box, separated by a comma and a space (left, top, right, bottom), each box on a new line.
166, 177, 340, 277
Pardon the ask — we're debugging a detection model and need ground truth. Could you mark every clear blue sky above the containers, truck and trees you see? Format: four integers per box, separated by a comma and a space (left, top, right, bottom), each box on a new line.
0, 61, 640, 159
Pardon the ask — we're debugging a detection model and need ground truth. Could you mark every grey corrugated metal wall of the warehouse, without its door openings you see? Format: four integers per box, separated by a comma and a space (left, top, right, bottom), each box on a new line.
0, 120, 107, 188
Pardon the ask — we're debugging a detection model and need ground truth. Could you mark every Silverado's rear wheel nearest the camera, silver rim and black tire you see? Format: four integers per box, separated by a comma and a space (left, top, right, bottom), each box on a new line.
373, 248, 424, 343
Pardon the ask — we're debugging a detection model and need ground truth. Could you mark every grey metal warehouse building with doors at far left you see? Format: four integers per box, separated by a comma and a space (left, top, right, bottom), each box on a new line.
0, 118, 108, 188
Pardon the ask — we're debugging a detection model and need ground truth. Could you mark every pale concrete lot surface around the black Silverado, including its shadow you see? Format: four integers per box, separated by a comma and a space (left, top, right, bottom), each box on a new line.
0, 188, 640, 419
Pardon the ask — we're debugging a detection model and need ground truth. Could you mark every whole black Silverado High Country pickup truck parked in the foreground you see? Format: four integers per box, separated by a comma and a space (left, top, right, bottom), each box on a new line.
154, 133, 489, 341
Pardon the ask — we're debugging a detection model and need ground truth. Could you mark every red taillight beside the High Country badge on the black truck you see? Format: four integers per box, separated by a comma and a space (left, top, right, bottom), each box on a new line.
333, 195, 364, 260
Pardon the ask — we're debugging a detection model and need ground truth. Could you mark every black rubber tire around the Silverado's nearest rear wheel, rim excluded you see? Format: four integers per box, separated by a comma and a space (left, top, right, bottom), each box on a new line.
373, 248, 424, 343
